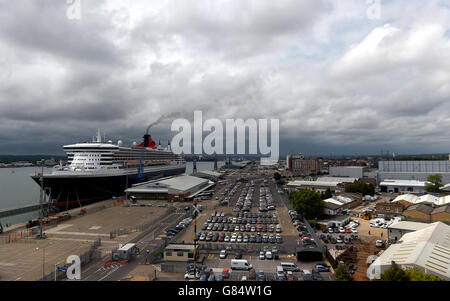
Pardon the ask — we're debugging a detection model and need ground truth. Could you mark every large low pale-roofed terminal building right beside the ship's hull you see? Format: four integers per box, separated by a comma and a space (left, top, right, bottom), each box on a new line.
126, 175, 214, 201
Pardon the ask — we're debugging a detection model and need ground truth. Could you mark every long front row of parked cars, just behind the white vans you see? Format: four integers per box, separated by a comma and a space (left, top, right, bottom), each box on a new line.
197, 232, 283, 244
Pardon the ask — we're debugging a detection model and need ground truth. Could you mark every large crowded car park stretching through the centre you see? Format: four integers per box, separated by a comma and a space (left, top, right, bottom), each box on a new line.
172, 168, 334, 281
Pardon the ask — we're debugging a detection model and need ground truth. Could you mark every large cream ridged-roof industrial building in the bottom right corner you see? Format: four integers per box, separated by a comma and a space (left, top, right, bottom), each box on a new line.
367, 222, 450, 281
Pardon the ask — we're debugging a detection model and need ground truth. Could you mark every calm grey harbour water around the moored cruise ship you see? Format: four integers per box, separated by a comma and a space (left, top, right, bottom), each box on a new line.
0, 162, 225, 225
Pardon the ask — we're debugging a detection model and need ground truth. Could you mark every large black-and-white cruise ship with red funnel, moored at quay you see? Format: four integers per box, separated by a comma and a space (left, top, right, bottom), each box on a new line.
31, 131, 186, 211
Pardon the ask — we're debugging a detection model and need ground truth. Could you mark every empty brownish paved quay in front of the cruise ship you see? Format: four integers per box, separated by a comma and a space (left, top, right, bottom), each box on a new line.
0, 200, 185, 281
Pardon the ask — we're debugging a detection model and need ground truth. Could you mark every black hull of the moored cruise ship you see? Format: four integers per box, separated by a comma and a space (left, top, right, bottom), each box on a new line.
31, 167, 186, 211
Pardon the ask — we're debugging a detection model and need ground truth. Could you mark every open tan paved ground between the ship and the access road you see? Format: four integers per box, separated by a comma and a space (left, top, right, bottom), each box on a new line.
0, 198, 181, 281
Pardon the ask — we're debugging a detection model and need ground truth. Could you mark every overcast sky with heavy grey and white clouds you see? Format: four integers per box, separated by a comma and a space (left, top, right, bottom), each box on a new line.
0, 0, 450, 155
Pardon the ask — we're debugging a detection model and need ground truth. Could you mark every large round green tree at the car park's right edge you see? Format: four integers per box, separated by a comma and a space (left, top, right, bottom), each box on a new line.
289, 189, 325, 219
